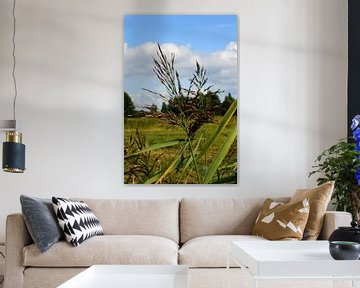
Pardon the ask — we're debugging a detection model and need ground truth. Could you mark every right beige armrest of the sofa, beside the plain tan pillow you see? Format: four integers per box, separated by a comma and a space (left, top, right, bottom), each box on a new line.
319, 211, 352, 240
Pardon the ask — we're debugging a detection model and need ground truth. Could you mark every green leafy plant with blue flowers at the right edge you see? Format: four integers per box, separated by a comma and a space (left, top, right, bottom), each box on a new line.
309, 115, 360, 223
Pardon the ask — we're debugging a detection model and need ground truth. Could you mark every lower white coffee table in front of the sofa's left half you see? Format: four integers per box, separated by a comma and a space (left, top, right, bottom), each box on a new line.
59, 265, 189, 288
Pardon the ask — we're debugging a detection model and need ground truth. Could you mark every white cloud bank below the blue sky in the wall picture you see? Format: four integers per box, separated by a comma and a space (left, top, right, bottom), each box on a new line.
124, 42, 238, 108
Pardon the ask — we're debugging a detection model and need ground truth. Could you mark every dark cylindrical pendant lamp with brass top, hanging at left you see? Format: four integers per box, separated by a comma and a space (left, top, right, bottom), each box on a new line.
2, 131, 25, 173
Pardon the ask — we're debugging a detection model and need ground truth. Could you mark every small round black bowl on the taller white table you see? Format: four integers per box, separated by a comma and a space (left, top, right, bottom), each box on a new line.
329, 241, 360, 260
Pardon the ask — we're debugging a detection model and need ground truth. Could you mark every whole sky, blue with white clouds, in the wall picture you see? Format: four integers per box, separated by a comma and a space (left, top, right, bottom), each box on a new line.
124, 15, 238, 107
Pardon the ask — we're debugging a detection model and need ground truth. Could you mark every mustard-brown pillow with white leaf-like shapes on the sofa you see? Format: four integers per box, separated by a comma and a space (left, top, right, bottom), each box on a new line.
252, 198, 309, 240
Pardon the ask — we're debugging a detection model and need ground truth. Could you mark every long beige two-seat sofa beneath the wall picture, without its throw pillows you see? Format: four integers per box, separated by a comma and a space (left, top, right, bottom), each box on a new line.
4, 198, 351, 288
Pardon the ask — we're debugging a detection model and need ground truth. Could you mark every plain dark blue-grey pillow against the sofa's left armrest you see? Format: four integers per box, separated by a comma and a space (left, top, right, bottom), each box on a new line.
20, 195, 64, 253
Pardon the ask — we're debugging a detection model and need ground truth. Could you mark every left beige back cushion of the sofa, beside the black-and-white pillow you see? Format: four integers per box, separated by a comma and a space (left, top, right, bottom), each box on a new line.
75, 198, 179, 243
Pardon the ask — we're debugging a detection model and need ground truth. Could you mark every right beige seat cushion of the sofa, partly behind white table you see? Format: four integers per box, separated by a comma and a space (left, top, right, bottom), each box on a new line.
179, 235, 268, 268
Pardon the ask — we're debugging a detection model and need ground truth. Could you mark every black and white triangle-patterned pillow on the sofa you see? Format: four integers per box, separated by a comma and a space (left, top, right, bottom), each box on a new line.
52, 197, 104, 246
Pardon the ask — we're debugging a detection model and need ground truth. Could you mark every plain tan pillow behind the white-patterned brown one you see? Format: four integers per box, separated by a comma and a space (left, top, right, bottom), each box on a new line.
289, 181, 335, 240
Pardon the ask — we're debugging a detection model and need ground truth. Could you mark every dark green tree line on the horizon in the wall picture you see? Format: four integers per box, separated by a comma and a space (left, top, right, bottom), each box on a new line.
124, 92, 235, 118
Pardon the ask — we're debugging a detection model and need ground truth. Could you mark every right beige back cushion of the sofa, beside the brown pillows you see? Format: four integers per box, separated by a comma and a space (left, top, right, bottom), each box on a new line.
180, 198, 288, 243
